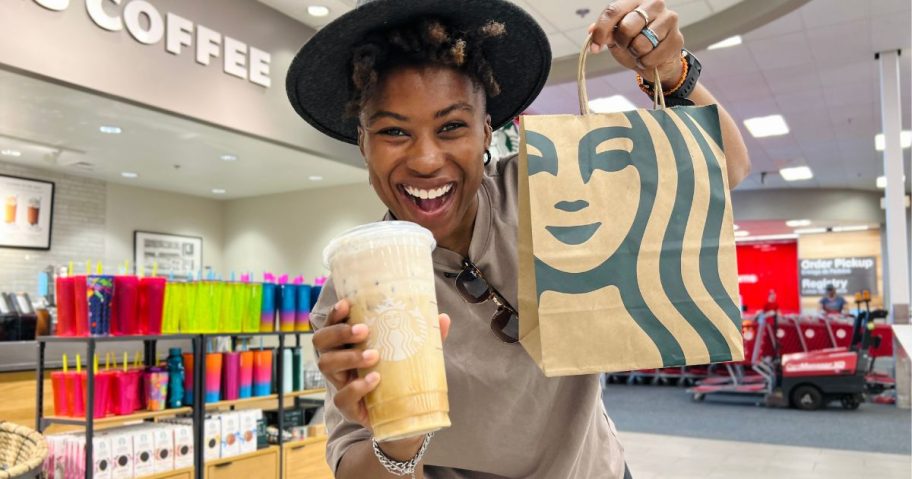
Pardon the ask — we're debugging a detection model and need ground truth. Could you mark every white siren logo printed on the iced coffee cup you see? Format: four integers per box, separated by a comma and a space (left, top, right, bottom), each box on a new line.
364, 297, 428, 361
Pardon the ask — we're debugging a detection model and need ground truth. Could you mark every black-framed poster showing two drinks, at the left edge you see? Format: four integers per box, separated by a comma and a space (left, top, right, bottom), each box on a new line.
0, 175, 54, 250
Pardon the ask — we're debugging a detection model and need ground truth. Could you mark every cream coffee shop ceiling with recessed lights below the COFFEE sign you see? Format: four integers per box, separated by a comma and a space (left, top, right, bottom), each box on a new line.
0, 69, 367, 199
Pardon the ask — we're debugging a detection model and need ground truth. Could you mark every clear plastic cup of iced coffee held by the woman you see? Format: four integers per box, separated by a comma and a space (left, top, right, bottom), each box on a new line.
323, 221, 450, 441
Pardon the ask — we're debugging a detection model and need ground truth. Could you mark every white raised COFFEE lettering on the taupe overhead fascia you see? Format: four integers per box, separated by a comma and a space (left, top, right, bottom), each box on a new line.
35, 0, 272, 88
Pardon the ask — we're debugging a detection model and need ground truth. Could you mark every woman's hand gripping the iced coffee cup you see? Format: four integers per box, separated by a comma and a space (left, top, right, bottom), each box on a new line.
313, 299, 450, 457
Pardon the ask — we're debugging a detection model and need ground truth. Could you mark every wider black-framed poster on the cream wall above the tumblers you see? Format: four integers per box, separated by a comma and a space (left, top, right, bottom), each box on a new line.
133, 231, 203, 279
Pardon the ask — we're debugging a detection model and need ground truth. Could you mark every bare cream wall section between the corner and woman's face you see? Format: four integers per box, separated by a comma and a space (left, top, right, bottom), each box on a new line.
225, 183, 386, 282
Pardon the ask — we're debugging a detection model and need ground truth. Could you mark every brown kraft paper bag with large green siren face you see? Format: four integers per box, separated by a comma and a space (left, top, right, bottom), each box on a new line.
519, 37, 744, 376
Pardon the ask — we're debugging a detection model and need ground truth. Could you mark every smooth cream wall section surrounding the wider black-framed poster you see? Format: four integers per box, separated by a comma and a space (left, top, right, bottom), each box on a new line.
105, 183, 224, 271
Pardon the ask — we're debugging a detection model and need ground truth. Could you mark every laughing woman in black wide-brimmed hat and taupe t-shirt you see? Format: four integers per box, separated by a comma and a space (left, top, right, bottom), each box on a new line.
287, 0, 748, 479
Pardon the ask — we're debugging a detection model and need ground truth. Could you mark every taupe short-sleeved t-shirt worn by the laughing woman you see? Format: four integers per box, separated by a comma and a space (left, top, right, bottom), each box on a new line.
311, 156, 624, 479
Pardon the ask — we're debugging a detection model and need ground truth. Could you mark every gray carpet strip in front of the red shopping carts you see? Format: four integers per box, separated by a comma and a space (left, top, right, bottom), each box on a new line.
604, 384, 912, 454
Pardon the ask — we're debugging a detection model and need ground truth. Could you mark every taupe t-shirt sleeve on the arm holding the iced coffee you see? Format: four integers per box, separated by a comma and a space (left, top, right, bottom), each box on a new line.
310, 278, 371, 474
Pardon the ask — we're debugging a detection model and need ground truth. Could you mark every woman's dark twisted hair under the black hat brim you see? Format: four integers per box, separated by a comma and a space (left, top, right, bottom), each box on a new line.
345, 18, 506, 117
